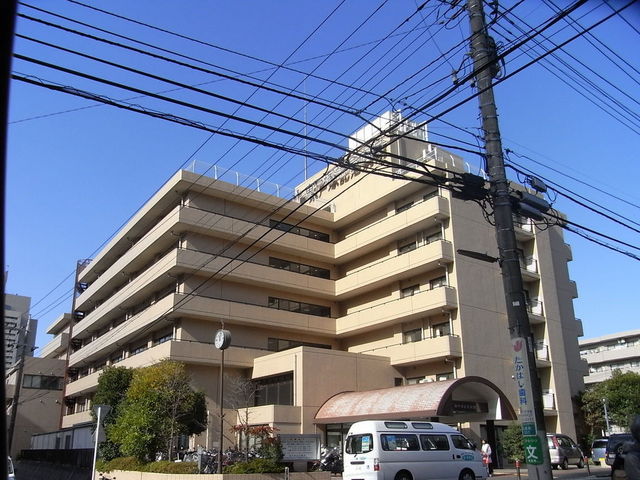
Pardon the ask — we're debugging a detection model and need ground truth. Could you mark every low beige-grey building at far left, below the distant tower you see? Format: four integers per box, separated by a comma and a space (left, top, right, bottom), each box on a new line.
6, 357, 65, 458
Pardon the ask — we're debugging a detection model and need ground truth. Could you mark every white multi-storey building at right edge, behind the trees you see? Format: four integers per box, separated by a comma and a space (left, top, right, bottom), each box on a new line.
580, 330, 640, 385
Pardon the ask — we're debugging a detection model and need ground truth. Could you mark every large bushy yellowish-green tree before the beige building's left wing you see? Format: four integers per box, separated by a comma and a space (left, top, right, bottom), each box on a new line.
107, 360, 206, 460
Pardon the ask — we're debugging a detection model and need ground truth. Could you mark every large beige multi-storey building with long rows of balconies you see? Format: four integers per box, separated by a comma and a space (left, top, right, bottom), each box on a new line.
43, 112, 587, 454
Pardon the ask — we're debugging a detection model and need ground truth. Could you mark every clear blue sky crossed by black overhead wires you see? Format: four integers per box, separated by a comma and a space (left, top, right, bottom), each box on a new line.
5, 0, 640, 347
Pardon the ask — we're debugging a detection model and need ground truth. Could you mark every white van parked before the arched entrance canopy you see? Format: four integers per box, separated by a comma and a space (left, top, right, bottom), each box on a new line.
342, 421, 487, 480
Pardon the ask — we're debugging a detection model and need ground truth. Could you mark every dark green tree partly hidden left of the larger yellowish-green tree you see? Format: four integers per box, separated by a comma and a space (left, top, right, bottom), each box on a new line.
91, 367, 133, 461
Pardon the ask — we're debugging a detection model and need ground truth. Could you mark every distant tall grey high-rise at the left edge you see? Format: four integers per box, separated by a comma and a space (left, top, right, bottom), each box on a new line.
4, 294, 38, 372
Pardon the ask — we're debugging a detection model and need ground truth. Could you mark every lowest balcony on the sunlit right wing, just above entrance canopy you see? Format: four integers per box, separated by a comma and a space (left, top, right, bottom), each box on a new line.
368, 335, 462, 367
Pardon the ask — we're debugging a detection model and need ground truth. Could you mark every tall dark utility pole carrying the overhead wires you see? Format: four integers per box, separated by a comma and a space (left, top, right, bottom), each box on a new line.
467, 0, 553, 480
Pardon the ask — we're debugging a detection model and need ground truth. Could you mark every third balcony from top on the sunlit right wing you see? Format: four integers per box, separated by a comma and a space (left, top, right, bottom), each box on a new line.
336, 287, 458, 335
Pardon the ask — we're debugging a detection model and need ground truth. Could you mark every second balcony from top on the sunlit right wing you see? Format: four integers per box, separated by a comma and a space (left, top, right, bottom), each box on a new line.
335, 240, 453, 300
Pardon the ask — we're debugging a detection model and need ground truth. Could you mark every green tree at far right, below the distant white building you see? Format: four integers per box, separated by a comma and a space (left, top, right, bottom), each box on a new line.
581, 370, 640, 436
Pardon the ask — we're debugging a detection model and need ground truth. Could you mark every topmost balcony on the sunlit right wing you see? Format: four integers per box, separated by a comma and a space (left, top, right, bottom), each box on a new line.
335, 197, 449, 263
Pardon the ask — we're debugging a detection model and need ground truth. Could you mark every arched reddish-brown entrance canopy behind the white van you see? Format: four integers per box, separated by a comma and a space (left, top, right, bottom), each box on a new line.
314, 376, 517, 424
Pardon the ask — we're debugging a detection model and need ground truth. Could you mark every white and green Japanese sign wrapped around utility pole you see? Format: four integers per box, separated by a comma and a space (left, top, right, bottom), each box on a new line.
511, 337, 543, 465
